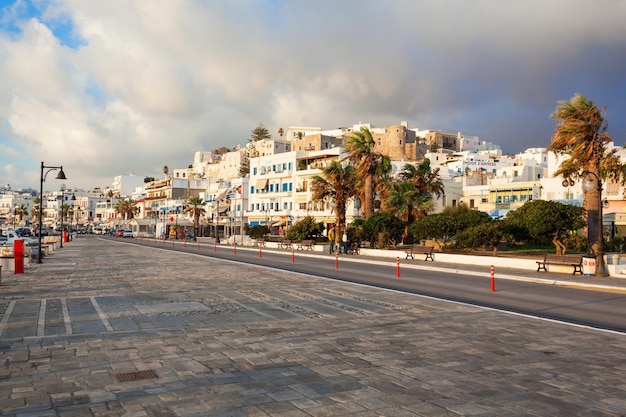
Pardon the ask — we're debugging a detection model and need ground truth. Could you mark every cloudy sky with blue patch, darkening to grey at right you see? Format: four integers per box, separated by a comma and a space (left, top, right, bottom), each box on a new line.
0, 0, 626, 191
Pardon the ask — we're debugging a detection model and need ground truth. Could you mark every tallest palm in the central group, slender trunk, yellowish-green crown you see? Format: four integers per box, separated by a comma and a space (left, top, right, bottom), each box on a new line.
344, 127, 384, 219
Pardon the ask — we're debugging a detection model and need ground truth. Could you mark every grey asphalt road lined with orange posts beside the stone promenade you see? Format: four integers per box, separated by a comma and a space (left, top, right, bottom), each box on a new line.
111, 238, 626, 333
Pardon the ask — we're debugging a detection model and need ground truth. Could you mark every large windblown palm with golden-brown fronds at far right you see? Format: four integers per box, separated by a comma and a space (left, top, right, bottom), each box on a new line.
548, 94, 623, 274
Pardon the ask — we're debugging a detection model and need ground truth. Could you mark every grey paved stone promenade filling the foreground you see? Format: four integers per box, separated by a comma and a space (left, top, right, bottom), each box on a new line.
0, 238, 626, 417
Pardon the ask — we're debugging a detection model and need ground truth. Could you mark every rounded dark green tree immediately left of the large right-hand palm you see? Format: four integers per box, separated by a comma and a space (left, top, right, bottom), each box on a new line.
504, 200, 585, 255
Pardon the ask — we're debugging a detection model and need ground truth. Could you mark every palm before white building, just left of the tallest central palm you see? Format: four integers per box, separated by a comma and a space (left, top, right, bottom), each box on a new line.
311, 161, 357, 242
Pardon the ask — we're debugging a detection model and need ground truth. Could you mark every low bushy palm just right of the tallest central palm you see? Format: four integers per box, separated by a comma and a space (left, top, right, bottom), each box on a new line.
387, 181, 434, 242
